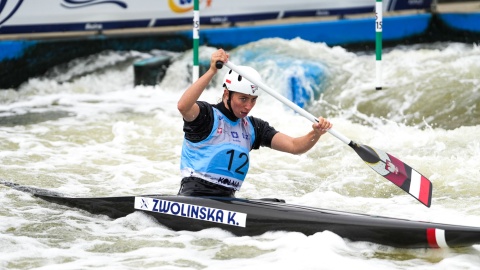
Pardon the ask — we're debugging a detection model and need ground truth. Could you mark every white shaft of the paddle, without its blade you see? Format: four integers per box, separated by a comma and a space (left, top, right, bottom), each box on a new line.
216, 61, 353, 146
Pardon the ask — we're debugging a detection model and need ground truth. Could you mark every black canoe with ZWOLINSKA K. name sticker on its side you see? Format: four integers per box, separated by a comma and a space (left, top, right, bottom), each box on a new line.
1, 181, 480, 248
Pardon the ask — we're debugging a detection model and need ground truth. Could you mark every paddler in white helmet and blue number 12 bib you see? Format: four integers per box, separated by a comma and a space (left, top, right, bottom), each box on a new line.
177, 49, 332, 197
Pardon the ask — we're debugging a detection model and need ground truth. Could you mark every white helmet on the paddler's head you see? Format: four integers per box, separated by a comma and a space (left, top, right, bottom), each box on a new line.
223, 66, 262, 96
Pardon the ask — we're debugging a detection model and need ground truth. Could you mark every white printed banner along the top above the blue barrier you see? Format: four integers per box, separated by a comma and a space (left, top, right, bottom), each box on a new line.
0, 0, 431, 34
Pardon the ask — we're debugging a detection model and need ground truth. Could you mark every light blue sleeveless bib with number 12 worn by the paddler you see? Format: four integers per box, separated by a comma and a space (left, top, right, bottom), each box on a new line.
180, 108, 255, 190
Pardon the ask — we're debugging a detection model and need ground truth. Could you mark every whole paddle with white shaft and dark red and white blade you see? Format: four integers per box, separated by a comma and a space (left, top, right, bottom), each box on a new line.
216, 61, 432, 207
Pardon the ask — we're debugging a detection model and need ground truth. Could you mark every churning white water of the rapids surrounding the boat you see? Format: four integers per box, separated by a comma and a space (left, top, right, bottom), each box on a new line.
0, 39, 480, 269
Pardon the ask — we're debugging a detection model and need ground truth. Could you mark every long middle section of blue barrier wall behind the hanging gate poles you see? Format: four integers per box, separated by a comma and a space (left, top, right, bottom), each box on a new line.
193, 14, 432, 47
